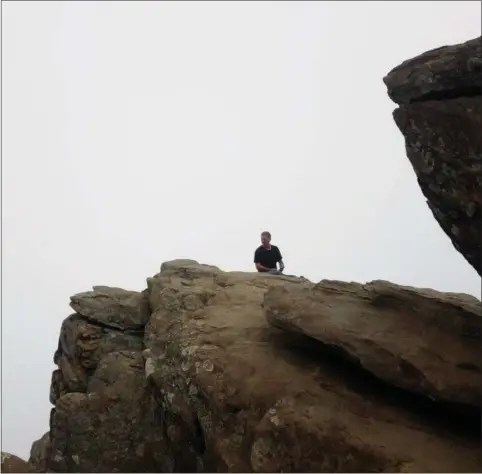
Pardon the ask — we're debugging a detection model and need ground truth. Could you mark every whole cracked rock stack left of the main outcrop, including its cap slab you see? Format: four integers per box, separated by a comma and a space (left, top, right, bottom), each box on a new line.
39, 286, 157, 472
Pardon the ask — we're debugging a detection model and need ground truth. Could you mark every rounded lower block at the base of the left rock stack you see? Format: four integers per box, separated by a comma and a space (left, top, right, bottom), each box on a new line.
49, 351, 170, 472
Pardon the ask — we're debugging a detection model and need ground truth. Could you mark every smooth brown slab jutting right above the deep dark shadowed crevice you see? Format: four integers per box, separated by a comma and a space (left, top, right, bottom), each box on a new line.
264, 281, 482, 409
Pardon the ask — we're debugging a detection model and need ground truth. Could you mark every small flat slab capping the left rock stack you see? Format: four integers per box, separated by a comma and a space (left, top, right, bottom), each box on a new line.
70, 286, 150, 330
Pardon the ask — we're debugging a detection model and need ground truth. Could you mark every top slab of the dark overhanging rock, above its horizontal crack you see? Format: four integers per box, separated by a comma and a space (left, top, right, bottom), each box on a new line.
383, 37, 482, 104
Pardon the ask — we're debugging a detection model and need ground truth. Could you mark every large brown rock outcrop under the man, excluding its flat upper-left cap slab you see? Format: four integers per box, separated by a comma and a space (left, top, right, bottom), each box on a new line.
30, 261, 481, 472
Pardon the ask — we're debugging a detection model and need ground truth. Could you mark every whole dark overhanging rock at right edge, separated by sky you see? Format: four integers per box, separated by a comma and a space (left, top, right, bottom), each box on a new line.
384, 38, 482, 275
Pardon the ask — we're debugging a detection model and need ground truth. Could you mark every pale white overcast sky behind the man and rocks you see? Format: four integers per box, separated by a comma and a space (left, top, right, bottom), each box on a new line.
2, 1, 480, 457
